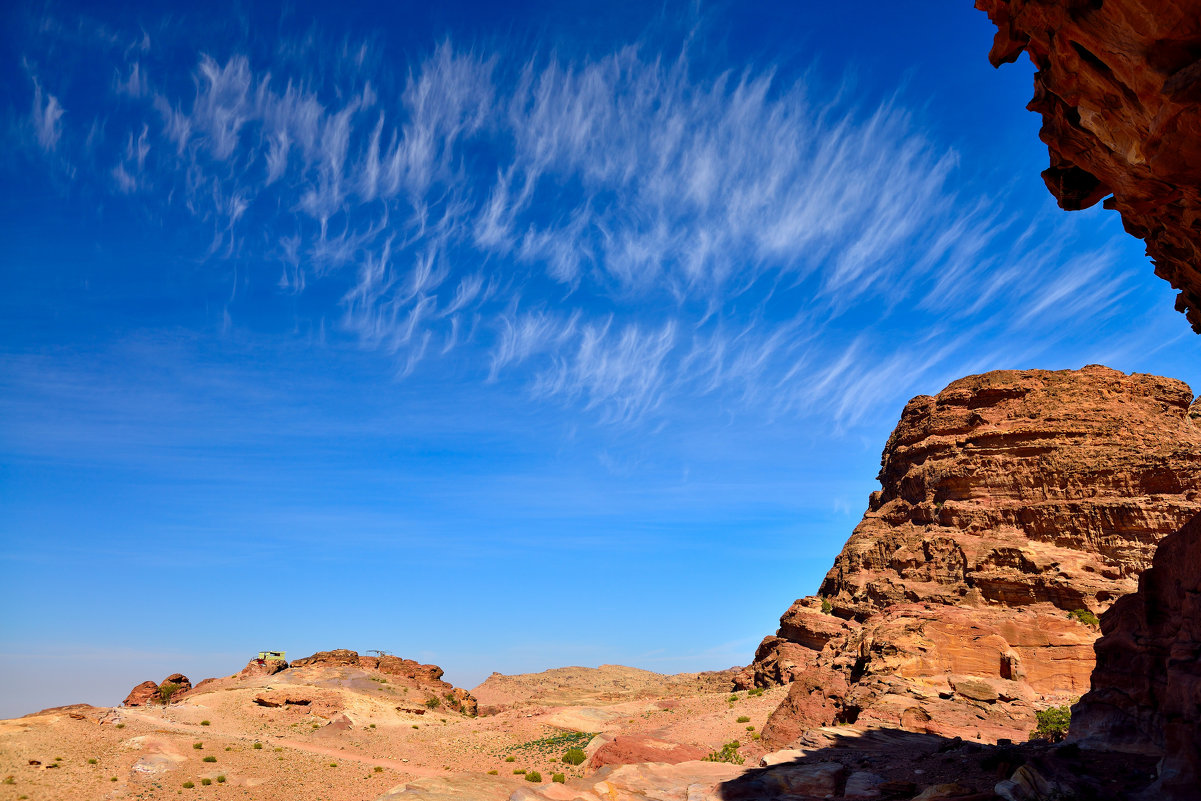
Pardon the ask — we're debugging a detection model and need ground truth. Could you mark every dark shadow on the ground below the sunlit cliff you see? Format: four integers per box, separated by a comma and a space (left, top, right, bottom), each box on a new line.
718, 729, 1155, 801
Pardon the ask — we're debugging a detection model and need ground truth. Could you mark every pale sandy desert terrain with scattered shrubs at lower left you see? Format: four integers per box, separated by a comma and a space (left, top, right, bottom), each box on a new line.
0, 665, 785, 801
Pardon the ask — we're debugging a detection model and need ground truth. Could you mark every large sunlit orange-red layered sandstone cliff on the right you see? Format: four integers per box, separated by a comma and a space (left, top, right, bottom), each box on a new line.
736, 366, 1201, 746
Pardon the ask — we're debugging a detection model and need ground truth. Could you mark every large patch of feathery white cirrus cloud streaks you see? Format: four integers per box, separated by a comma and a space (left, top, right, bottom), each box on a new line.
14, 10, 1143, 424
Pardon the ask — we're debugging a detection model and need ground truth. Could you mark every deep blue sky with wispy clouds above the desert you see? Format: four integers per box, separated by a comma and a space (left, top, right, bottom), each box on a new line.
0, 2, 1201, 716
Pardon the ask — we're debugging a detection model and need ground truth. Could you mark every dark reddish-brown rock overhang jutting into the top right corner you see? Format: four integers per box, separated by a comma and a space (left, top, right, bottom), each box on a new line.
975, 0, 1201, 333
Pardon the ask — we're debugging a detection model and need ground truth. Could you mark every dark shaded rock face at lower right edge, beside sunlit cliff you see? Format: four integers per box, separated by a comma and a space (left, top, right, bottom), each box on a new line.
1070, 516, 1201, 800
